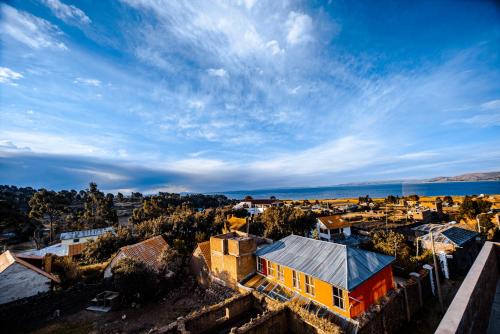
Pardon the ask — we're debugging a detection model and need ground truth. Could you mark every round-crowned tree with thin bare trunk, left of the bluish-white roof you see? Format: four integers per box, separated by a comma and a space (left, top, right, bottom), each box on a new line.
29, 189, 69, 242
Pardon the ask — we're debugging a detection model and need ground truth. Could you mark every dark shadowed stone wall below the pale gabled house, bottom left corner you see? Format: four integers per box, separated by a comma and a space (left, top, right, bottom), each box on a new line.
0, 284, 105, 333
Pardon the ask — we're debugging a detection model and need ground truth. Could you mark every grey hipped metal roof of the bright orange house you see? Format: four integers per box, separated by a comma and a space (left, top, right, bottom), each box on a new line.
255, 235, 394, 291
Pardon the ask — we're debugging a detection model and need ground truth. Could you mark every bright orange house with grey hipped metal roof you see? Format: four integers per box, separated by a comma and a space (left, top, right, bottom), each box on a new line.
255, 235, 394, 318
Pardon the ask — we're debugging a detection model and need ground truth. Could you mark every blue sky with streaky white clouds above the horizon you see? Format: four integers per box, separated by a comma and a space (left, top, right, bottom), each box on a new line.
0, 0, 500, 192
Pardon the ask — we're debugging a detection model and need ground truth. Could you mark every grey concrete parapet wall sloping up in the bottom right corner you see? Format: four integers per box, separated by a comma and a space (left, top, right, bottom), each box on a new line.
435, 242, 500, 334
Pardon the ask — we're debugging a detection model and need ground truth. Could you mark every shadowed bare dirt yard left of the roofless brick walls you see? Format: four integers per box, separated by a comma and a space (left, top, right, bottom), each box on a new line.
31, 282, 231, 334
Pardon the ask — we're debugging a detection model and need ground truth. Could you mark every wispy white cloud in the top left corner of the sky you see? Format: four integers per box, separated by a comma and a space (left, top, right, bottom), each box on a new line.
0, 4, 68, 50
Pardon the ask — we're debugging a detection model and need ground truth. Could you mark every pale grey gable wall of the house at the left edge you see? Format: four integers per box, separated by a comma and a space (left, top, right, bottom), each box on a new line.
0, 263, 51, 304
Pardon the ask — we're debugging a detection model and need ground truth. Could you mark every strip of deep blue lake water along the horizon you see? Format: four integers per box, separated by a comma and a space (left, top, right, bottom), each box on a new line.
221, 181, 500, 199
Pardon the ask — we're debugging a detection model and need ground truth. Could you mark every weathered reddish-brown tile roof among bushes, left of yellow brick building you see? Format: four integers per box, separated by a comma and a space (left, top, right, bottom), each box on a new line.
120, 235, 168, 270
